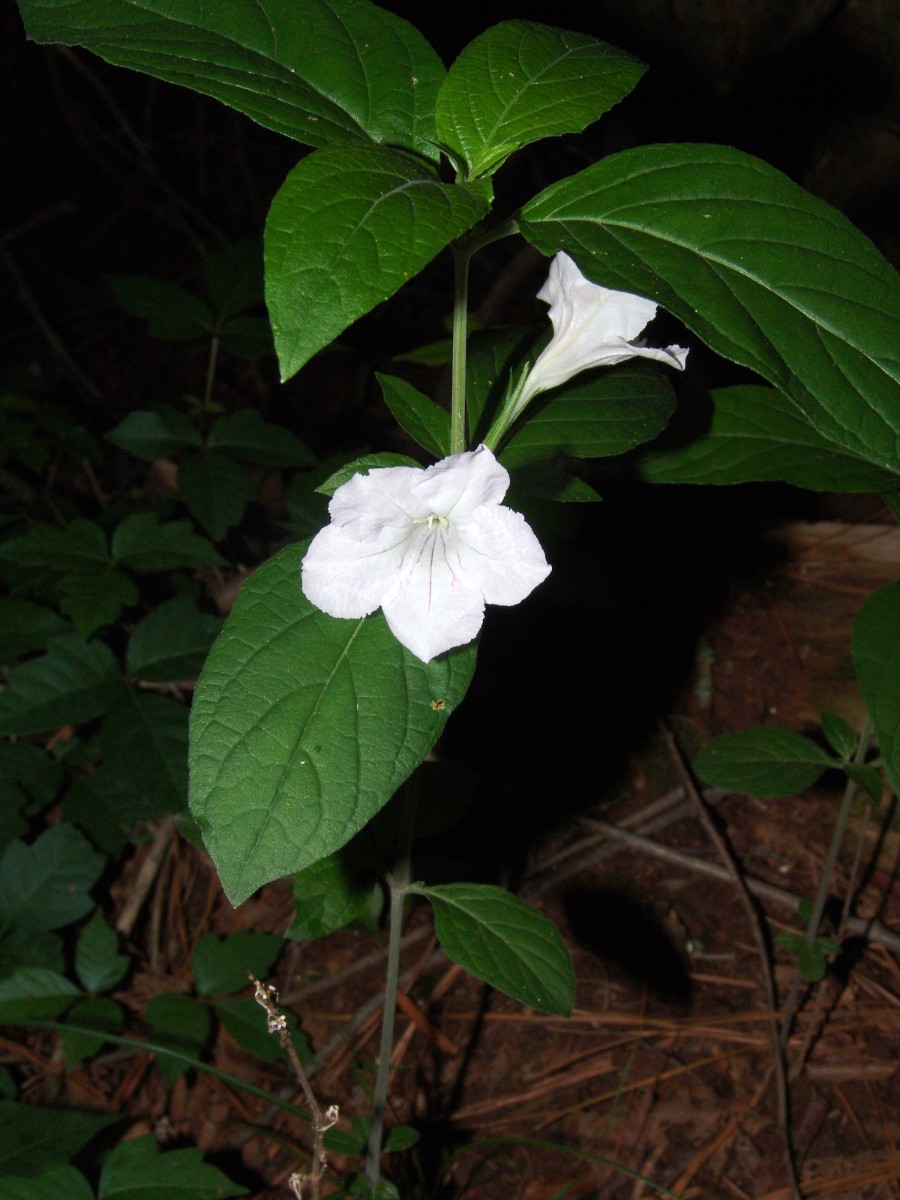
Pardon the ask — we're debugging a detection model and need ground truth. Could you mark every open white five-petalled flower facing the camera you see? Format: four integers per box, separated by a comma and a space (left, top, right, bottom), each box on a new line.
301, 445, 550, 662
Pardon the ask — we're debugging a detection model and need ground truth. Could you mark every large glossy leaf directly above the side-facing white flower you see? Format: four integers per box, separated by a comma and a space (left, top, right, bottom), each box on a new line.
520, 145, 900, 473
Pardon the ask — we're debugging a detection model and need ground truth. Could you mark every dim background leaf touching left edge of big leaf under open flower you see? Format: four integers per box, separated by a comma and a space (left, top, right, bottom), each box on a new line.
98, 688, 188, 817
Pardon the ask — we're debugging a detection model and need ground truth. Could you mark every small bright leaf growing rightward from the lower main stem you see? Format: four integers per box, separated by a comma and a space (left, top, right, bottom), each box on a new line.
410, 883, 575, 1016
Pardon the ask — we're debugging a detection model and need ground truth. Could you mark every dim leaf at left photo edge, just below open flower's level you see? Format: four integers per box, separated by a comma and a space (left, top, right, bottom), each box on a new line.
0, 634, 122, 733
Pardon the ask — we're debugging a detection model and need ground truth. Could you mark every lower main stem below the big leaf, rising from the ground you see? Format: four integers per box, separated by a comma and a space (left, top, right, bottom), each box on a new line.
366, 772, 422, 1190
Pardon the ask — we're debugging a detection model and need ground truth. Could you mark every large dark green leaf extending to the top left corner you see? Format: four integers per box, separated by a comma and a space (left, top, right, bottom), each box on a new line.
19, 0, 444, 157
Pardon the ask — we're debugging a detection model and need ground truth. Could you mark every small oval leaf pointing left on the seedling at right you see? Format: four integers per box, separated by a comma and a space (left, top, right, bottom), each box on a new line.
694, 725, 840, 797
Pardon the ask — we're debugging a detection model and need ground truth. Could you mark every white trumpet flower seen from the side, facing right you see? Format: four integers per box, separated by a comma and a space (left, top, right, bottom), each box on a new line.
510, 251, 688, 420
